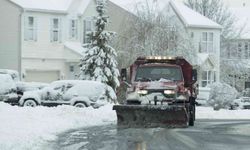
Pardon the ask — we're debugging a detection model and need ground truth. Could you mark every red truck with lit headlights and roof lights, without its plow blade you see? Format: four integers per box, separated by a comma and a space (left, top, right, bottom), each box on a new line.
122, 56, 197, 104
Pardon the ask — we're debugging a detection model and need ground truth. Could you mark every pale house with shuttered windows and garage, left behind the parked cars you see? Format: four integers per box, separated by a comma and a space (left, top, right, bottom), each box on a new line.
0, 0, 133, 82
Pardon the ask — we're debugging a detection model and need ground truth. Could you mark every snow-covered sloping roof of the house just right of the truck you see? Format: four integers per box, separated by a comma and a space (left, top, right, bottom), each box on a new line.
170, 0, 222, 29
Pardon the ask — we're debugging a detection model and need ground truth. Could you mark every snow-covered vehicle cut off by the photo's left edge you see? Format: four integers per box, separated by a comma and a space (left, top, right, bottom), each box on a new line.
0, 74, 18, 103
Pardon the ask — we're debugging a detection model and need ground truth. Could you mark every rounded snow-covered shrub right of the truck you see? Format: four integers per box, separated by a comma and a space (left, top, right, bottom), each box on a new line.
208, 82, 238, 110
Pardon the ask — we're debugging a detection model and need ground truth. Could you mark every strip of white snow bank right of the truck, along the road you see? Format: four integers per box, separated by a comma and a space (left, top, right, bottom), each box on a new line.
196, 107, 250, 120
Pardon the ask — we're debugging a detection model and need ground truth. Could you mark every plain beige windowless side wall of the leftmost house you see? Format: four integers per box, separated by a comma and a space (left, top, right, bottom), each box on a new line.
0, 0, 23, 72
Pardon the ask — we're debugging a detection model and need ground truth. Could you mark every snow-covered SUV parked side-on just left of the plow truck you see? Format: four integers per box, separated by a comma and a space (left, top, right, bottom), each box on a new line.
19, 80, 116, 108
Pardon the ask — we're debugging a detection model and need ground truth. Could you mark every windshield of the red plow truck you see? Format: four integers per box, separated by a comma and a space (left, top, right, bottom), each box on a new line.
135, 66, 182, 81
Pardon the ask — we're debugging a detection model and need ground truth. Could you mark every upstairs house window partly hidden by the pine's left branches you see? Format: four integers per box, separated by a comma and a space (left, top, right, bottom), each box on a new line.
83, 18, 94, 43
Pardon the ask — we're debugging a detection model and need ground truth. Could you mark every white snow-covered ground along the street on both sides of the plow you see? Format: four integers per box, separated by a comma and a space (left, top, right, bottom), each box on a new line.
0, 102, 250, 150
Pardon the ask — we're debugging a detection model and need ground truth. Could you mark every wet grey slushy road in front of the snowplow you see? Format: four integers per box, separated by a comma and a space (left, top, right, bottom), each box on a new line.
51, 120, 250, 150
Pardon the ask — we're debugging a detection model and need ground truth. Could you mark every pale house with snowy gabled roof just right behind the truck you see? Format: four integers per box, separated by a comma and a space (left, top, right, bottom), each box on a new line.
164, 0, 222, 99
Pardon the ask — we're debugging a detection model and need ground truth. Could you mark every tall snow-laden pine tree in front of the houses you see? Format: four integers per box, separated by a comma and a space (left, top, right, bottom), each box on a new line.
80, 0, 120, 97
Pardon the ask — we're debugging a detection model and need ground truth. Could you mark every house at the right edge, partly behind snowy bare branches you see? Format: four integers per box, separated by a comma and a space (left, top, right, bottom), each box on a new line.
222, 5, 250, 91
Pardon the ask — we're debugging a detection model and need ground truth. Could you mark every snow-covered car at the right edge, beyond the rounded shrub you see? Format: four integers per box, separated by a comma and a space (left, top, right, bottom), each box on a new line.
230, 97, 250, 109
